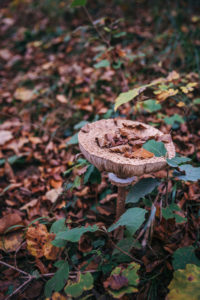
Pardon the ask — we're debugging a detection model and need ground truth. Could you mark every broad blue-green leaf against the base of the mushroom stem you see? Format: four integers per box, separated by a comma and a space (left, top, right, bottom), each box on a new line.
108, 207, 147, 235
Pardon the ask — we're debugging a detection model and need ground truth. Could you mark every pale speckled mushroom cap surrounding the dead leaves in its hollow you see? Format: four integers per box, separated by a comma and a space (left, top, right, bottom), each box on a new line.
78, 119, 175, 178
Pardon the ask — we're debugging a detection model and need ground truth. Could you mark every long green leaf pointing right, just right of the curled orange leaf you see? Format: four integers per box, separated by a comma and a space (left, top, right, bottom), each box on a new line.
56, 225, 99, 243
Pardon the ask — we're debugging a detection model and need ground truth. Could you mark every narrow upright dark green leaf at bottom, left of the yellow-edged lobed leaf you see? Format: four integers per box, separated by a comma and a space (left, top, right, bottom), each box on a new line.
44, 260, 69, 298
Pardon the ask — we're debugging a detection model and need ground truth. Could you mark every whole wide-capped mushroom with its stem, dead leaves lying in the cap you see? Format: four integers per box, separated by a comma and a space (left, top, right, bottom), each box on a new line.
78, 119, 175, 220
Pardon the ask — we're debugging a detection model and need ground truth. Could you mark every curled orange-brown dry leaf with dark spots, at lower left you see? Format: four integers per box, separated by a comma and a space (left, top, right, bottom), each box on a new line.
26, 224, 60, 260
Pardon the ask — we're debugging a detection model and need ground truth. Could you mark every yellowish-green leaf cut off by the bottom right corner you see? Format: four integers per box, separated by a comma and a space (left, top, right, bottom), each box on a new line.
166, 264, 200, 300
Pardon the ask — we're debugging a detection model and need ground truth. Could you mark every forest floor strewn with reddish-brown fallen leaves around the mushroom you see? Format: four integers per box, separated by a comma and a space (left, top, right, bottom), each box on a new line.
0, 0, 200, 300
